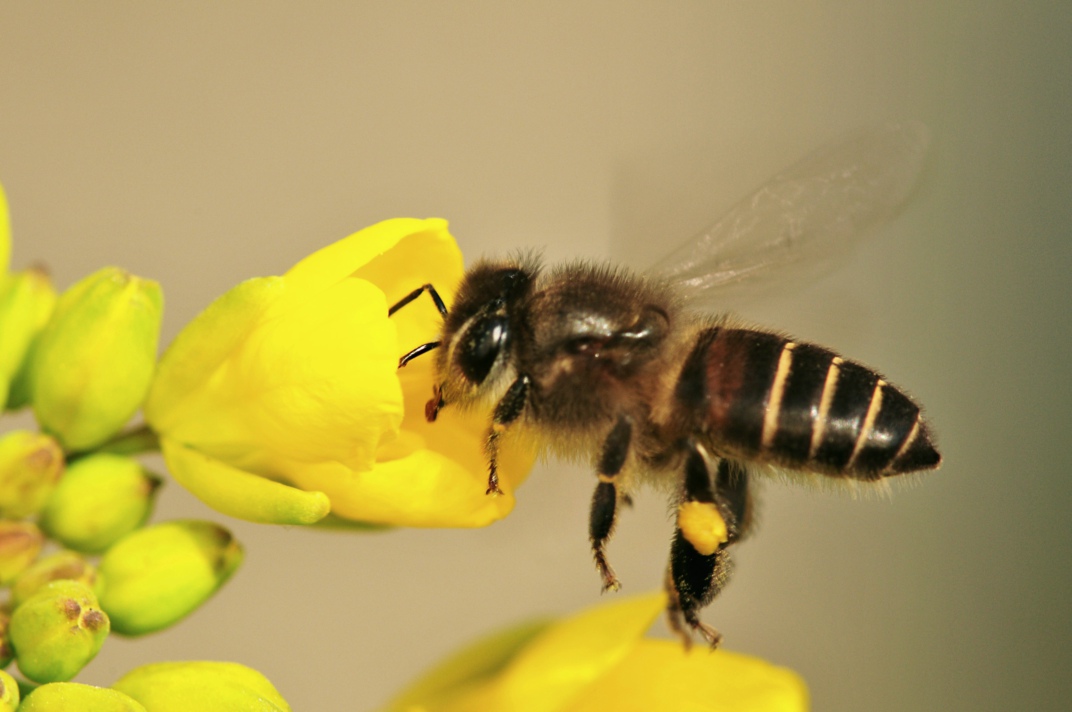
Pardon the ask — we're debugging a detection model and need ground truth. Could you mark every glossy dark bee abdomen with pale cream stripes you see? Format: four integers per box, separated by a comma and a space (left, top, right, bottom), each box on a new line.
676, 327, 941, 479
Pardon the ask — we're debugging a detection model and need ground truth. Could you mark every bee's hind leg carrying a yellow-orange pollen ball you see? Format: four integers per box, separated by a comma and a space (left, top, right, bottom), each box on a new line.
666, 450, 748, 648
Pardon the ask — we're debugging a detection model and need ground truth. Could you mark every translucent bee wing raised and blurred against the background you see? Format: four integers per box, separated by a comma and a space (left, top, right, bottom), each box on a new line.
649, 122, 929, 306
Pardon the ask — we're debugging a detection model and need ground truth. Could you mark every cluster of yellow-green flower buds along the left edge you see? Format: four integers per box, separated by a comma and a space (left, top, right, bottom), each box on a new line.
0, 189, 289, 712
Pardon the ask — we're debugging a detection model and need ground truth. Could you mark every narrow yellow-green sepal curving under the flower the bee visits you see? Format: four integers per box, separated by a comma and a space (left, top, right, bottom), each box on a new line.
161, 437, 331, 524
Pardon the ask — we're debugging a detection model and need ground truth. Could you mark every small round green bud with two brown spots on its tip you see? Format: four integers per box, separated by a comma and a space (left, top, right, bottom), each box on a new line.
11, 581, 108, 682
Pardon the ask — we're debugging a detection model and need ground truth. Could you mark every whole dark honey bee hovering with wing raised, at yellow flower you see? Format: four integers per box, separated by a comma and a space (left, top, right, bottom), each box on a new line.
390, 123, 941, 647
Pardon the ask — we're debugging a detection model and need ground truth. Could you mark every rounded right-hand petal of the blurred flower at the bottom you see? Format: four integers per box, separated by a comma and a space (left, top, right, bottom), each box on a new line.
562, 640, 808, 712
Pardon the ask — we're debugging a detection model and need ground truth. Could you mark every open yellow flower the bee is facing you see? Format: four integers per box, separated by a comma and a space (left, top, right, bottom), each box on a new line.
145, 219, 533, 526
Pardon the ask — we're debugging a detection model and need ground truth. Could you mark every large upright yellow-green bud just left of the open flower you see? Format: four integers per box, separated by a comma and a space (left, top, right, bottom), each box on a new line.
29, 267, 163, 450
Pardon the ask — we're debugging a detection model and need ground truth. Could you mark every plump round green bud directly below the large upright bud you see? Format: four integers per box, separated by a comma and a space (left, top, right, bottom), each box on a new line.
41, 454, 160, 553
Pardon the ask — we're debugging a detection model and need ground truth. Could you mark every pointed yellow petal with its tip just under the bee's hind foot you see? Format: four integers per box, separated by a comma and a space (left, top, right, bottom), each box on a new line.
497, 593, 666, 712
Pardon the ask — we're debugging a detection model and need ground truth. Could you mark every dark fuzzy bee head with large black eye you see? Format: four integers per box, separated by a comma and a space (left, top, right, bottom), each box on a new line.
426, 262, 534, 420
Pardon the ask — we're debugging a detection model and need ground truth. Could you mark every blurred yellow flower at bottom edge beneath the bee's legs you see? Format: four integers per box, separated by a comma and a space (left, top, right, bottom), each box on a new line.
388, 594, 808, 712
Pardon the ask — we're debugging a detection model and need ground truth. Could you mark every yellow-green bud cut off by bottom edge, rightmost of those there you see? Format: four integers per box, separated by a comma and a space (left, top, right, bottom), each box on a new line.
113, 663, 291, 712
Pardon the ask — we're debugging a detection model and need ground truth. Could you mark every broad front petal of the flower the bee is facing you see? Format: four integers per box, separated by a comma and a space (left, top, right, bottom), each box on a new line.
148, 278, 402, 476
